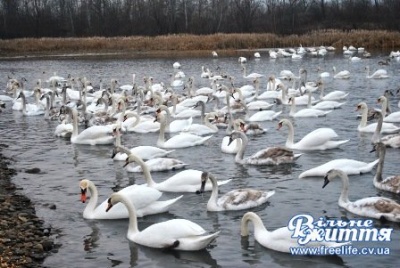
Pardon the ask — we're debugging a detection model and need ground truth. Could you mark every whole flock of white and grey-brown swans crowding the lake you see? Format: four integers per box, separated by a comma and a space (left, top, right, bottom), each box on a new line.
0, 47, 400, 258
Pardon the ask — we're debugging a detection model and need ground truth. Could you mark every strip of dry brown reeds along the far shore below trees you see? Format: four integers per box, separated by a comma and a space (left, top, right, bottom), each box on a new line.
0, 30, 400, 56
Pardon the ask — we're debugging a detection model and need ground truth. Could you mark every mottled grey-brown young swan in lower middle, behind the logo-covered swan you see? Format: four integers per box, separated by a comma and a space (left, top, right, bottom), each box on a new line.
196, 172, 275, 211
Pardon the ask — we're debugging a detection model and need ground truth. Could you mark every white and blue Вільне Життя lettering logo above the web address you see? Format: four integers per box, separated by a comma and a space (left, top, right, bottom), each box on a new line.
287, 214, 393, 246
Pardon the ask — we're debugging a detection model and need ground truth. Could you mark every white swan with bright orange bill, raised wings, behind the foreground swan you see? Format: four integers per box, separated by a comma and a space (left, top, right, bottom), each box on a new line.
79, 179, 183, 220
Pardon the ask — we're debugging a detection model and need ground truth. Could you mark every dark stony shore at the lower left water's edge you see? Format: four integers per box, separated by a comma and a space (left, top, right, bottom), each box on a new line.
0, 144, 60, 268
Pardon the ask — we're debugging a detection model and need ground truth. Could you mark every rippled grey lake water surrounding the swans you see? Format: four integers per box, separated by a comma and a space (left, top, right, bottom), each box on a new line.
0, 51, 400, 268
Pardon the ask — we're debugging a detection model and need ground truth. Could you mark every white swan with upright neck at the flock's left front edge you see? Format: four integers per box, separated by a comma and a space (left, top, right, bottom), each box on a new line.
62, 106, 115, 145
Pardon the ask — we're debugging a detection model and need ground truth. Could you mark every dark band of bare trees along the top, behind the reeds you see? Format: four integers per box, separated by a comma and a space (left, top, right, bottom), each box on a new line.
0, 0, 400, 39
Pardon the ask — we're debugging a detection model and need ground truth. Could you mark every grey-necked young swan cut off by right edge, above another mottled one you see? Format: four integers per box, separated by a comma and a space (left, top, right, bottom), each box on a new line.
371, 142, 400, 194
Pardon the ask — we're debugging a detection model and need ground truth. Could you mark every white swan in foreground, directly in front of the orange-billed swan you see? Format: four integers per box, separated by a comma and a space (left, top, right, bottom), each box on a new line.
106, 193, 219, 250
